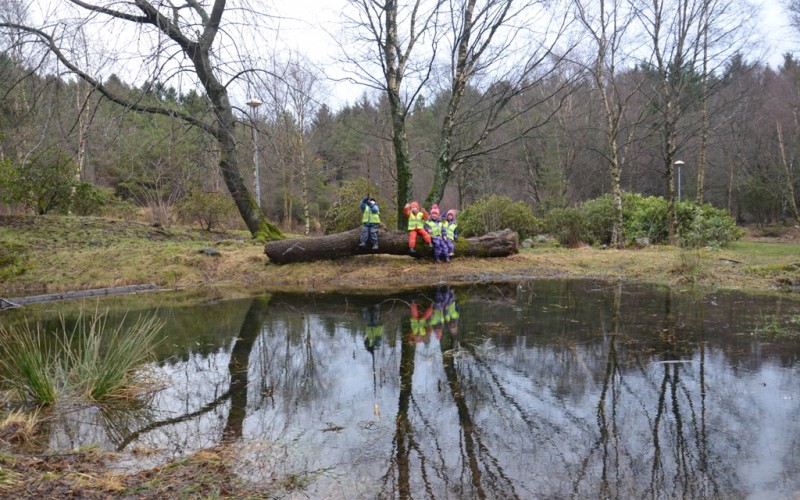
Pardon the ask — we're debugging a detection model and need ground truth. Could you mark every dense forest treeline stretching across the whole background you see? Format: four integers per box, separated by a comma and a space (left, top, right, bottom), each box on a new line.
0, 0, 800, 242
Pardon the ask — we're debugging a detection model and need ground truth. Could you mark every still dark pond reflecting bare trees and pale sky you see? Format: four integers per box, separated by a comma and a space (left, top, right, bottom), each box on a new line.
0, 280, 800, 498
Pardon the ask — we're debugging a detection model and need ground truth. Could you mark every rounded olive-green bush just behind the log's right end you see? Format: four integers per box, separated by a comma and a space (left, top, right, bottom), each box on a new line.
458, 195, 541, 239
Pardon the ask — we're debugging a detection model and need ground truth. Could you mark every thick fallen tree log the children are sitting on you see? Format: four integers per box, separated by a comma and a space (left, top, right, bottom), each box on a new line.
264, 228, 518, 264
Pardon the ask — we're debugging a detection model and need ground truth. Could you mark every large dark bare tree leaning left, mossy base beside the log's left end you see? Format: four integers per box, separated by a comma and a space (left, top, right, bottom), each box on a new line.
0, 0, 282, 239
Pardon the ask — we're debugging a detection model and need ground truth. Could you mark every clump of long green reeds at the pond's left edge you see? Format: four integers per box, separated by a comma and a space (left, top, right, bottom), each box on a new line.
0, 312, 163, 405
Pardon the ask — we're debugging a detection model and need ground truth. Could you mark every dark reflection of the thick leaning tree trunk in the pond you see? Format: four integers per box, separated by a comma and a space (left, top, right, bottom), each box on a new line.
222, 297, 269, 441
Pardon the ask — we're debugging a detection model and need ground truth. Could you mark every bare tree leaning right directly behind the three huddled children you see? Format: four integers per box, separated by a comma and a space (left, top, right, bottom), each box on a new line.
425, 0, 571, 204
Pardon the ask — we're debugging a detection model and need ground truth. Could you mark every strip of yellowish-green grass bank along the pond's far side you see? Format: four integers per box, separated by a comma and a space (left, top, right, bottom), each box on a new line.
0, 216, 800, 297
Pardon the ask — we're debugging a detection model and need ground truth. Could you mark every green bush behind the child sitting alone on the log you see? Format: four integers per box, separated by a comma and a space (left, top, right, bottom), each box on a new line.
322, 177, 397, 234
